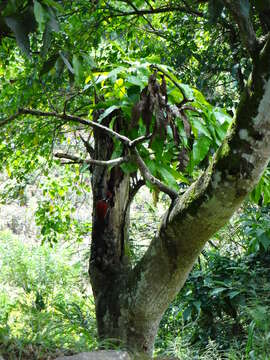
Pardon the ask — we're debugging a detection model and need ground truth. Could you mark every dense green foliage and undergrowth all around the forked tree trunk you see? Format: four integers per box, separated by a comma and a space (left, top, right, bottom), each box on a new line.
0, 0, 270, 359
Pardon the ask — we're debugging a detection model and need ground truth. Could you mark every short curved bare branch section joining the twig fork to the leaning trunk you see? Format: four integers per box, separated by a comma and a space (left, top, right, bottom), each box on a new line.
131, 148, 178, 199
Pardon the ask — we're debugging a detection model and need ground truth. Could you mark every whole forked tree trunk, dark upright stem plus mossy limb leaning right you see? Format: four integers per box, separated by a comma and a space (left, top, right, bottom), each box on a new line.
87, 35, 270, 355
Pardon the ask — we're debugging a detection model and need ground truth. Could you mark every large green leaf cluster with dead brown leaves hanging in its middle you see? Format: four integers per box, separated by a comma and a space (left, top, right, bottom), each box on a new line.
86, 60, 231, 189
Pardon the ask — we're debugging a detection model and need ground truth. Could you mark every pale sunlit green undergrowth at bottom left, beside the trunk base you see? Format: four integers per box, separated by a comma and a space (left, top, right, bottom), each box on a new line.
0, 232, 97, 359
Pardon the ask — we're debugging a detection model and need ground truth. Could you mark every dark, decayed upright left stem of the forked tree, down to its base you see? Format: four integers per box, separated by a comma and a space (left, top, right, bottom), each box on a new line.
89, 121, 159, 359
